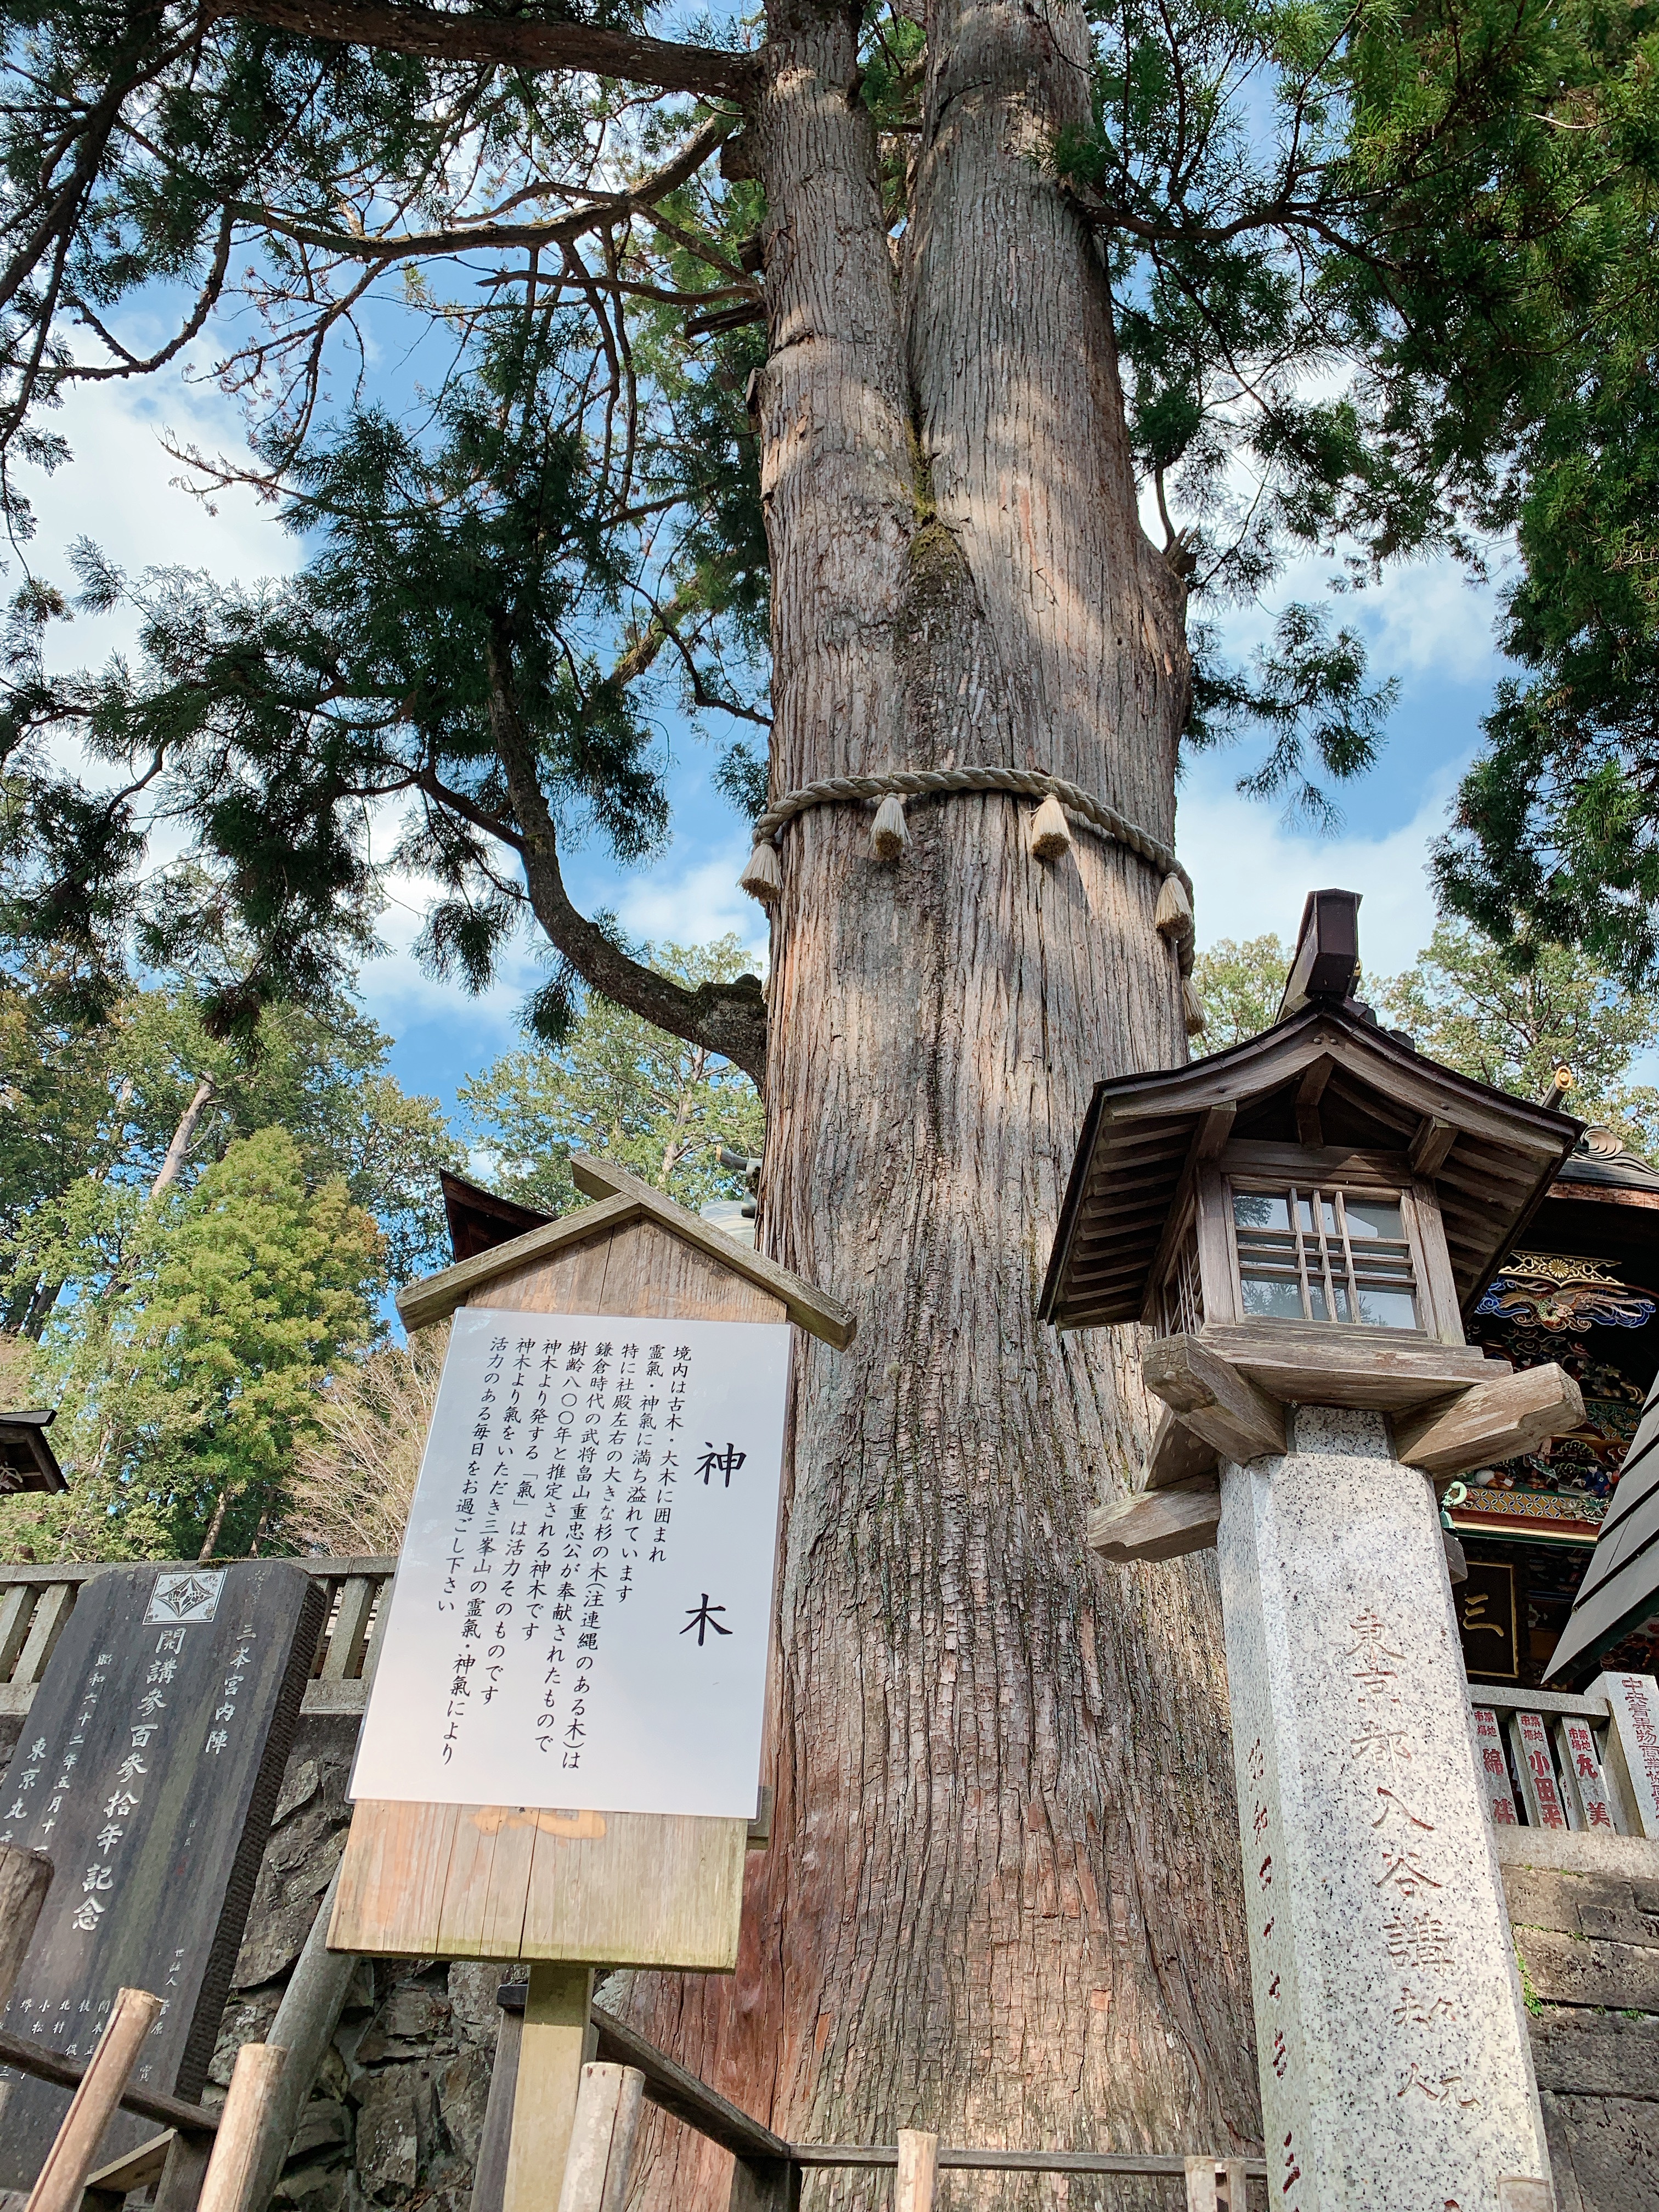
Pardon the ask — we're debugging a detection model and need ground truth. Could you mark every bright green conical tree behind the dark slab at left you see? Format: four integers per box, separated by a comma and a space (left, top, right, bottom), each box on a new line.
0, 1128, 385, 1558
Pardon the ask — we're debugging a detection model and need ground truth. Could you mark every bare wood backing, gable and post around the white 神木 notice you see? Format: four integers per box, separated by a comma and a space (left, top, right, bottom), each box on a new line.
330, 1159, 851, 2212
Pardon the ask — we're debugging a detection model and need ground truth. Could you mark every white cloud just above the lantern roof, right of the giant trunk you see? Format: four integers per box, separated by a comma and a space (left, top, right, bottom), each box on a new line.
1177, 763, 1460, 975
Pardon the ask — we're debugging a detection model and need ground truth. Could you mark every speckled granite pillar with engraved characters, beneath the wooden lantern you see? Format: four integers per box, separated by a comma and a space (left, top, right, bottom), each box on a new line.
1219, 1407, 1546, 2212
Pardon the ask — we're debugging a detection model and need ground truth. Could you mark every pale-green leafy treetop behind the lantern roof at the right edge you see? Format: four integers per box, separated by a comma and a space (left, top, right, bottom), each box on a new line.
1374, 920, 1659, 1153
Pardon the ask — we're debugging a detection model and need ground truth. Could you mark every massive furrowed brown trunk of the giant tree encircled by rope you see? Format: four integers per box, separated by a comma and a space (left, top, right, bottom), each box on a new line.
608, 0, 1259, 2205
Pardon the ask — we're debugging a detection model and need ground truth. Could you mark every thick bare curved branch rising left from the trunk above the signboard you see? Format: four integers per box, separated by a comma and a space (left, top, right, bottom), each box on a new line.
489, 635, 765, 1086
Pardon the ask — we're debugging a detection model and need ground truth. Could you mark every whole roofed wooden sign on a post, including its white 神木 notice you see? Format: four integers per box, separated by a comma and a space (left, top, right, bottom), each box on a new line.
330, 1157, 854, 2212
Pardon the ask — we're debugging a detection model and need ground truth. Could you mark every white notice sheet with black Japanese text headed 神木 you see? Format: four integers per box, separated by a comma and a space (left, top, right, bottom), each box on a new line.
352, 1307, 789, 1818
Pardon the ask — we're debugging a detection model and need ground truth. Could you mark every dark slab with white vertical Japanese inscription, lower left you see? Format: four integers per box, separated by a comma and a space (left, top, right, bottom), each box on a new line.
0, 1560, 323, 2188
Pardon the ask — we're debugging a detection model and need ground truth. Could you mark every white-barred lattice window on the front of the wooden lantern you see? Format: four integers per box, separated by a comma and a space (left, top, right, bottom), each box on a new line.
1232, 1183, 1423, 1329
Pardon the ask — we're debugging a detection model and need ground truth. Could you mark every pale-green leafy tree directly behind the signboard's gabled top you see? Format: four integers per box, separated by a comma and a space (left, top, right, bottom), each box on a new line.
458, 936, 765, 1215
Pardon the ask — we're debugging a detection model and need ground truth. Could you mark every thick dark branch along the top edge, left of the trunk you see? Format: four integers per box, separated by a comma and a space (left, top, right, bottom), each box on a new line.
201, 0, 757, 99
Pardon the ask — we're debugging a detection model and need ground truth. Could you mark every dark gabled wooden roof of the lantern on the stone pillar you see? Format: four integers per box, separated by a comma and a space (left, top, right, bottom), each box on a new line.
1037, 1000, 1584, 1329
